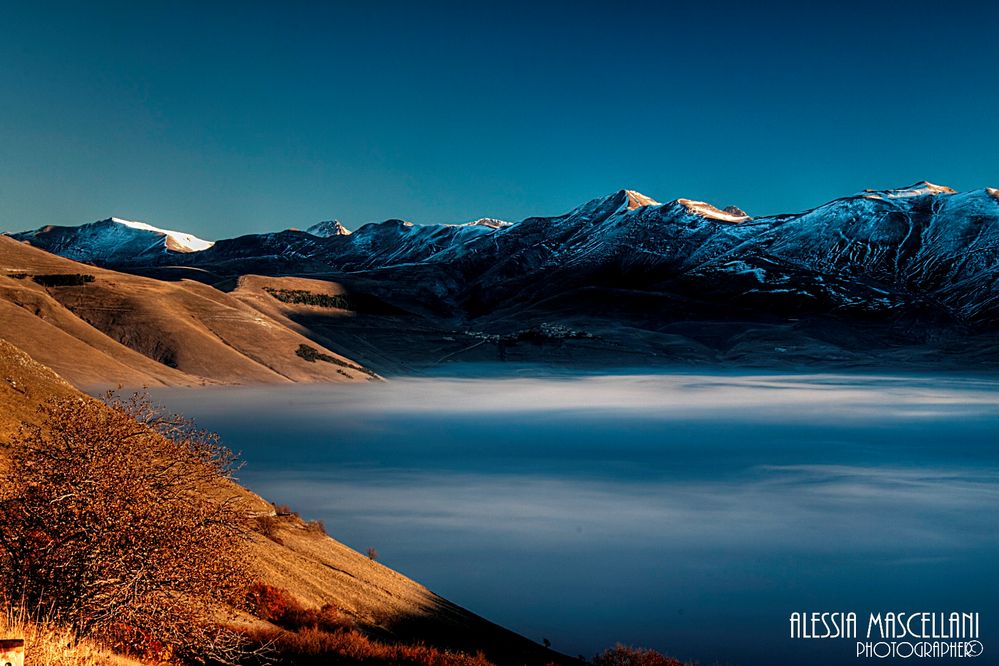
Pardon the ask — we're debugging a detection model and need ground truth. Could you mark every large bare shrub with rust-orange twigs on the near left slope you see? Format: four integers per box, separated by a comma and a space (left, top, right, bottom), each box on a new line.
0, 394, 254, 658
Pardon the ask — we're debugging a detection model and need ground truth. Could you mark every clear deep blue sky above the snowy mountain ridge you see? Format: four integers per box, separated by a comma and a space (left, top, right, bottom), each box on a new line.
0, 0, 999, 238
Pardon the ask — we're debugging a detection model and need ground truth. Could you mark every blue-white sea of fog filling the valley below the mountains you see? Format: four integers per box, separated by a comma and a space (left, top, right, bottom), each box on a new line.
148, 373, 999, 666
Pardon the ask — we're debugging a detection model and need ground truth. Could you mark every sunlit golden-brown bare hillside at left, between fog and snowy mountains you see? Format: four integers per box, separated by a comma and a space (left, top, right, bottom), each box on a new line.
0, 235, 370, 387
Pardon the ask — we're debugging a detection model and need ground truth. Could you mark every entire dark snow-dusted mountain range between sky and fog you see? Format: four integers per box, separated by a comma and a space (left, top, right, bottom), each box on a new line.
7, 182, 999, 372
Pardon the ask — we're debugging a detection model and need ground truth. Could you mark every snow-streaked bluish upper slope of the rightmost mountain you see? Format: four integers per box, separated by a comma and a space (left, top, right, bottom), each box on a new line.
705, 183, 999, 321
